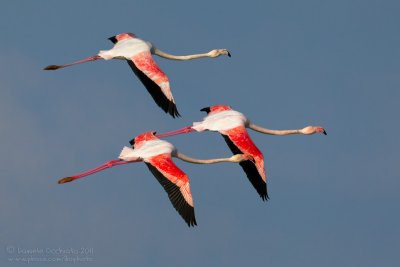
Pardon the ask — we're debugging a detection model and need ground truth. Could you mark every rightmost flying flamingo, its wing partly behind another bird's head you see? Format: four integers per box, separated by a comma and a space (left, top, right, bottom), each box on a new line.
155, 105, 326, 201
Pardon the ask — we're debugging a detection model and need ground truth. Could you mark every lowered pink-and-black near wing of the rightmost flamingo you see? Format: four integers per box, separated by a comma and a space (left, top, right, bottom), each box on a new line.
222, 129, 269, 201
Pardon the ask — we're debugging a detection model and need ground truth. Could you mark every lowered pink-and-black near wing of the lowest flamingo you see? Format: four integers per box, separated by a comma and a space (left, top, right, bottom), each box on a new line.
146, 154, 197, 227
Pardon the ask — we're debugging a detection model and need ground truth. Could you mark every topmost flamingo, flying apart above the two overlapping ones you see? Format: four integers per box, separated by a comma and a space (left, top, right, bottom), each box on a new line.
44, 33, 231, 118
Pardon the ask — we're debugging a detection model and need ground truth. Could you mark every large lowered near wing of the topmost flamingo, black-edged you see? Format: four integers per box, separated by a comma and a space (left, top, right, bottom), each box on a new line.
128, 52, 180, 118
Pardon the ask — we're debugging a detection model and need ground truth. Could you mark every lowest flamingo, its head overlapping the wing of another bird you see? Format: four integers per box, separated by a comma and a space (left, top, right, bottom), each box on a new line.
58, 132, 251, 227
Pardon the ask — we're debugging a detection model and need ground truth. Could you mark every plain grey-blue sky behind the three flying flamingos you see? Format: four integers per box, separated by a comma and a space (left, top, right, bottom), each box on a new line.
0, 0, 400, 266
